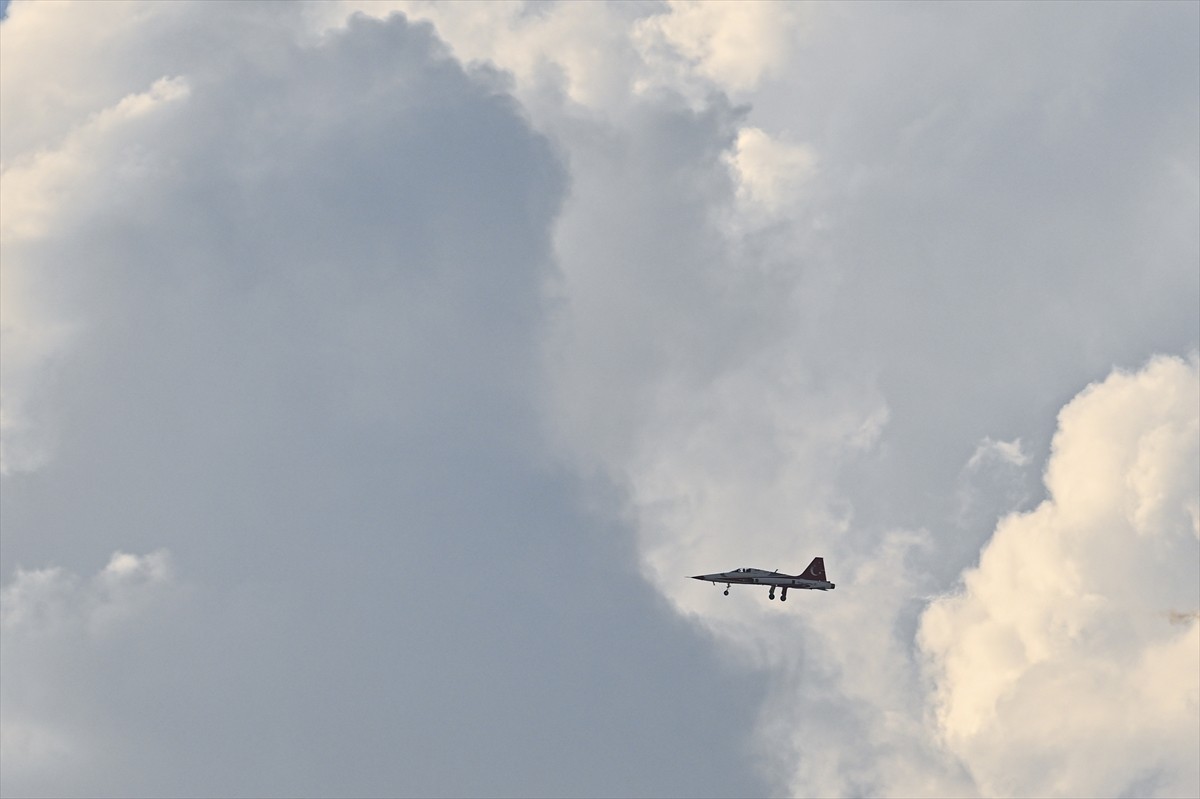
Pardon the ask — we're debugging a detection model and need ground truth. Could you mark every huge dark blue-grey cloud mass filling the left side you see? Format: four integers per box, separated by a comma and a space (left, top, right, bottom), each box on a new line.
0, 4, 764, 795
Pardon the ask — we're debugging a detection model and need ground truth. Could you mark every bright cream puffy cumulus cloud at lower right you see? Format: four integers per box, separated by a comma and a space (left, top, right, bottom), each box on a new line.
918, 358, 1200, 795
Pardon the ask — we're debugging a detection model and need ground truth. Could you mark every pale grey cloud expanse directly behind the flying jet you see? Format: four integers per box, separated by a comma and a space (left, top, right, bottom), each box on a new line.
352, 6, 1198, 795
